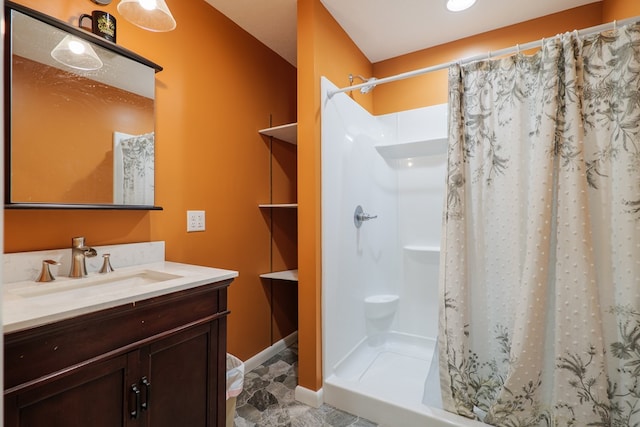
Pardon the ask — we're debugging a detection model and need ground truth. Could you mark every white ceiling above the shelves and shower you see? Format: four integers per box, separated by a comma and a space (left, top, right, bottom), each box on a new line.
205, 0, 601, 65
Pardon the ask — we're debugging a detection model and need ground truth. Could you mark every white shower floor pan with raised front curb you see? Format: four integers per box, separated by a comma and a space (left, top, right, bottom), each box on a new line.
323, 332, 484, 427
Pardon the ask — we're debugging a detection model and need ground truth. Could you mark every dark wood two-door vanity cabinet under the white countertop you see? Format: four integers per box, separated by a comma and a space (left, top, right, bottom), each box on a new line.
4, 280, 231, 427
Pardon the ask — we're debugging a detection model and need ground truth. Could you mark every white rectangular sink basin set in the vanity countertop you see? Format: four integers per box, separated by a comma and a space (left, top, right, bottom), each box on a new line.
9, 269, 182, 298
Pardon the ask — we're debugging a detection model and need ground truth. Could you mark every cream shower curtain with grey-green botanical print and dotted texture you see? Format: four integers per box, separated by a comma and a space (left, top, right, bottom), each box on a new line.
439, 25, 640, 427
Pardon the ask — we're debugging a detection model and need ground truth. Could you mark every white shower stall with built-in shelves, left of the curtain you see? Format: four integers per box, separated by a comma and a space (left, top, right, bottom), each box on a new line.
321, 78, 476, 427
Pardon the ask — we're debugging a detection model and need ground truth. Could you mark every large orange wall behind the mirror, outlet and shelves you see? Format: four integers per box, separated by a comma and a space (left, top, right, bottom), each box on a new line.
4, 0, 297, 359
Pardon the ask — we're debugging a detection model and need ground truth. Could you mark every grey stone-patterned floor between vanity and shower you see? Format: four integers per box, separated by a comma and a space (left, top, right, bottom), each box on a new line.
235, 344, 377, 427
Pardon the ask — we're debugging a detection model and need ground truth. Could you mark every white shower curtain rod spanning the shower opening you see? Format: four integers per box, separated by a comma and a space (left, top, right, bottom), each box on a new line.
328, 16, 640, 98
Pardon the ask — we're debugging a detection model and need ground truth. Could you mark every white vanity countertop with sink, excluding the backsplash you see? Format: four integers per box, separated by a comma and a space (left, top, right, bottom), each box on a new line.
2, 261, 238, 333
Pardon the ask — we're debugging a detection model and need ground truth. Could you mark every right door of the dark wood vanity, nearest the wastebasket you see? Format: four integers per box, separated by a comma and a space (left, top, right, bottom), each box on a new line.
141, 321, 221, 427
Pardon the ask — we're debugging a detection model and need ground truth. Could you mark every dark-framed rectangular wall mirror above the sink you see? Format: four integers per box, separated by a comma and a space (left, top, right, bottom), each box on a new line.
5, 2, 162, 209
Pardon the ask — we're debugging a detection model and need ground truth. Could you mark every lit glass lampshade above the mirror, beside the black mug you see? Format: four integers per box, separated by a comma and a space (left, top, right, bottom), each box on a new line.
118, 0, 176, 32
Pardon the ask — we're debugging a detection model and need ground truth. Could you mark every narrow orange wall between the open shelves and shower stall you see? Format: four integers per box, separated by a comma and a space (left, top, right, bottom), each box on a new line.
298, 0, 372, 390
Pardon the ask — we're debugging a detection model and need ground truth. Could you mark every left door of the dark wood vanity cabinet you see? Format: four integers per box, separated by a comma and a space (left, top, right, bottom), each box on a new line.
5, 355, 129, 427
